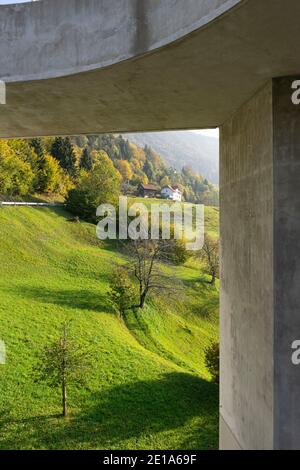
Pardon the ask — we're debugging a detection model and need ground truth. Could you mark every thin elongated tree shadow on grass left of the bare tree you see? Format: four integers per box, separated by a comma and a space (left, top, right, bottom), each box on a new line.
10, 286, 112, 313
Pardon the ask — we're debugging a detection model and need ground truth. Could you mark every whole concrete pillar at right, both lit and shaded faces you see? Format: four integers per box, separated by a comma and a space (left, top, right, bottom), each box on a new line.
220, 77, 300, 449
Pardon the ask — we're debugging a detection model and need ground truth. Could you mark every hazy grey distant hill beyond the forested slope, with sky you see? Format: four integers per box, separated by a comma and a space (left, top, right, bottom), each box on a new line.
124, 131, 219, 184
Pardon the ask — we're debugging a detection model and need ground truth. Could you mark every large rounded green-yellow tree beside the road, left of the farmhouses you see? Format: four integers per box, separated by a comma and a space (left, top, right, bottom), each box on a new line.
66, 152, 121, 222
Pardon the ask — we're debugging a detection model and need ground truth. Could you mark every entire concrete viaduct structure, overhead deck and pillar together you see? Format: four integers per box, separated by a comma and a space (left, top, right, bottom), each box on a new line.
0, 0, 300, 449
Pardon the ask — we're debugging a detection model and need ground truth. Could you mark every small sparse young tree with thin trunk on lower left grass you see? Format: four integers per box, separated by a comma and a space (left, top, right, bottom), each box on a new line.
34, 321, 90, 416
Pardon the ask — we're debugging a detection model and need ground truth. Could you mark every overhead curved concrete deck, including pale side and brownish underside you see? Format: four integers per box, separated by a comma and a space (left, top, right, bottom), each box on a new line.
0, 0, 300, 137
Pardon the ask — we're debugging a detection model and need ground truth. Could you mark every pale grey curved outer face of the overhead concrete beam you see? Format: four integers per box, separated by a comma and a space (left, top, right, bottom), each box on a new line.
0, 0, 241, 82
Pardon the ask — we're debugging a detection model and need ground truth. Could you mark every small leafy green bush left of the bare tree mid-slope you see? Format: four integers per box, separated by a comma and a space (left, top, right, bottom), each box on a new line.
108, 267, 136, 318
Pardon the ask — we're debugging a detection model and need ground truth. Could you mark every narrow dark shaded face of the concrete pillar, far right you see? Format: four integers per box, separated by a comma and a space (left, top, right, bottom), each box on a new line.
273, 76, 300, 450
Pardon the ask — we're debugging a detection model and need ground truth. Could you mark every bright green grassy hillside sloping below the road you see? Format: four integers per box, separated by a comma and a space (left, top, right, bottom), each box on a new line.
0, 207, 218, 449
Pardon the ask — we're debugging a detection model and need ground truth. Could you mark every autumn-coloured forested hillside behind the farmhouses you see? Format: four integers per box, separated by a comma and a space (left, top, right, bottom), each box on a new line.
0, 134, 218, 206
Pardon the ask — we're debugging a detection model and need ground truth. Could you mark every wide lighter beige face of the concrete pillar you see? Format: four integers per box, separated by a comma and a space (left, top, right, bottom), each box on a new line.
220, 82, 274, 450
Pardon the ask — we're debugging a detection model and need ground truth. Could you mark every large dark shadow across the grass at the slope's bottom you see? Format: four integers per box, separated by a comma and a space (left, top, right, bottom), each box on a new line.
0, 372, 218, 449
